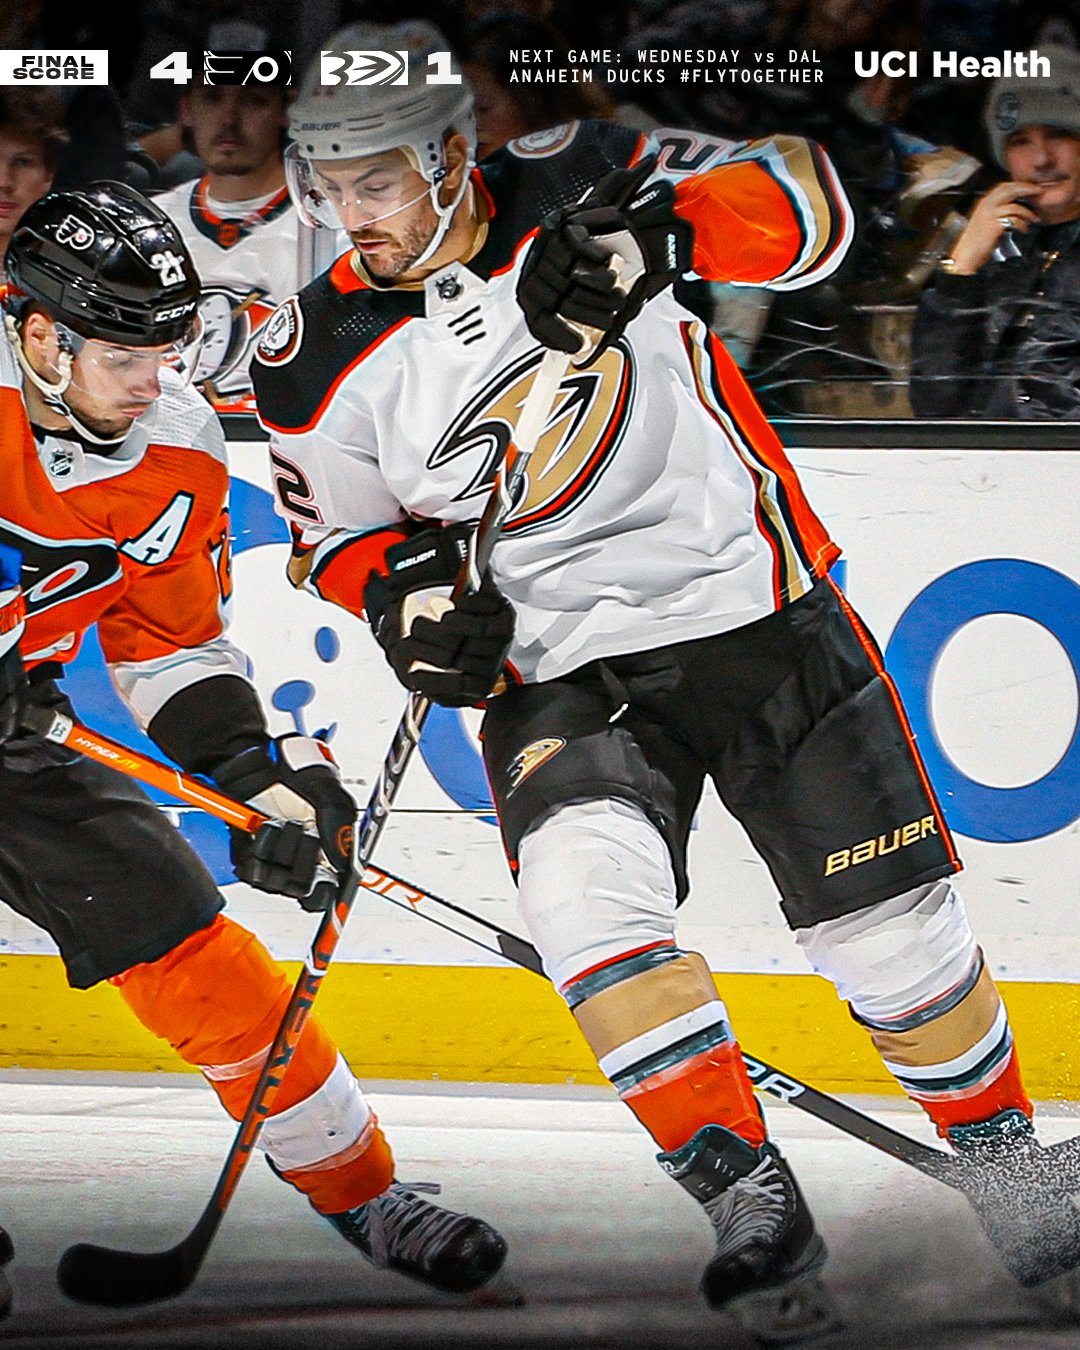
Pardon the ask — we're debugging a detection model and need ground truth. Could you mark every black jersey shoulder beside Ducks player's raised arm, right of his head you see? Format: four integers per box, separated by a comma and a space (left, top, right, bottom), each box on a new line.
468, 122, 644, 277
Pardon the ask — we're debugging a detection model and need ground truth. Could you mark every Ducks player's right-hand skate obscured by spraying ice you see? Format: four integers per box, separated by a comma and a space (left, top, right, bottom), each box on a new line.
948, 1110, 1080, 1288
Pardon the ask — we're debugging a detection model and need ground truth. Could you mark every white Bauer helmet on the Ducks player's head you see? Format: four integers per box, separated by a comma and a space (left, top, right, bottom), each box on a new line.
285, 20, 477, 262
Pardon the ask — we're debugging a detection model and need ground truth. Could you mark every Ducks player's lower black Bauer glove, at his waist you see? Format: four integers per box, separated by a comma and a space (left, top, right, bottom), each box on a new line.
363, 525, 514, 707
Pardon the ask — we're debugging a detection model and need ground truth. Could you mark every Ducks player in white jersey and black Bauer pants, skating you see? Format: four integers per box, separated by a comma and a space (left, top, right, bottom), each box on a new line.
252, 44, 1069, 1331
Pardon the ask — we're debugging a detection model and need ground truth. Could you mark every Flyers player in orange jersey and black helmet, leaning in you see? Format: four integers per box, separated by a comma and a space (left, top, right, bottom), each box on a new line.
0, 184, 505, 1289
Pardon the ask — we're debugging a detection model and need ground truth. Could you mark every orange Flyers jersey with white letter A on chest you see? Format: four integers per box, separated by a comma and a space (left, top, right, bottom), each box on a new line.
0, 328, 246, 724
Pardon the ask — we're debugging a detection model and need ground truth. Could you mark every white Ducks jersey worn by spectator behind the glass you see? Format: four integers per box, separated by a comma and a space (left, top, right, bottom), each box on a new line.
155, 178, 348, 413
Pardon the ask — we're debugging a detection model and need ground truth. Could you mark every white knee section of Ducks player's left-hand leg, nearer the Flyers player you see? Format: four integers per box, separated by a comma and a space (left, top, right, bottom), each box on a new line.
518, 799, 675, 992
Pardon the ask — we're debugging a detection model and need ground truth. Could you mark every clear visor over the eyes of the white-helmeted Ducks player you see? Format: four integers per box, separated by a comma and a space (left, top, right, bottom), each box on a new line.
285, 143, 441, 231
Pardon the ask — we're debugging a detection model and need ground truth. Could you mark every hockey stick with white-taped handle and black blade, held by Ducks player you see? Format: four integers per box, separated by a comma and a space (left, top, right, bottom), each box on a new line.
48, 351, 570, 1307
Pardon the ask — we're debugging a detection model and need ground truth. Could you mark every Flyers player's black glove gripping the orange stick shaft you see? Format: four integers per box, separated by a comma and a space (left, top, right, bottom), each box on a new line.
213, 734, 356, 913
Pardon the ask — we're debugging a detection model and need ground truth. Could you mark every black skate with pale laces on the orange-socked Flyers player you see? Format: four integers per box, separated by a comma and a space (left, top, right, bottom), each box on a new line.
324, 1181, 506, 1293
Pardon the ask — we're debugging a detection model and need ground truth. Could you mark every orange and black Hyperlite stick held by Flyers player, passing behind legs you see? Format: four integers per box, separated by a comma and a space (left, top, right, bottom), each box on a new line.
27, 709, 1080, 1301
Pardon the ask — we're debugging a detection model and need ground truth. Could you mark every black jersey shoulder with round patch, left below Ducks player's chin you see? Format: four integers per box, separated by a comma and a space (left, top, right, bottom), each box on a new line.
251, 259, 424, 431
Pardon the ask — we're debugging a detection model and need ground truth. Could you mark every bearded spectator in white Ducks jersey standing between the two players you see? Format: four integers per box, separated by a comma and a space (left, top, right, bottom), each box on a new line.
155, 76, 341, 413
